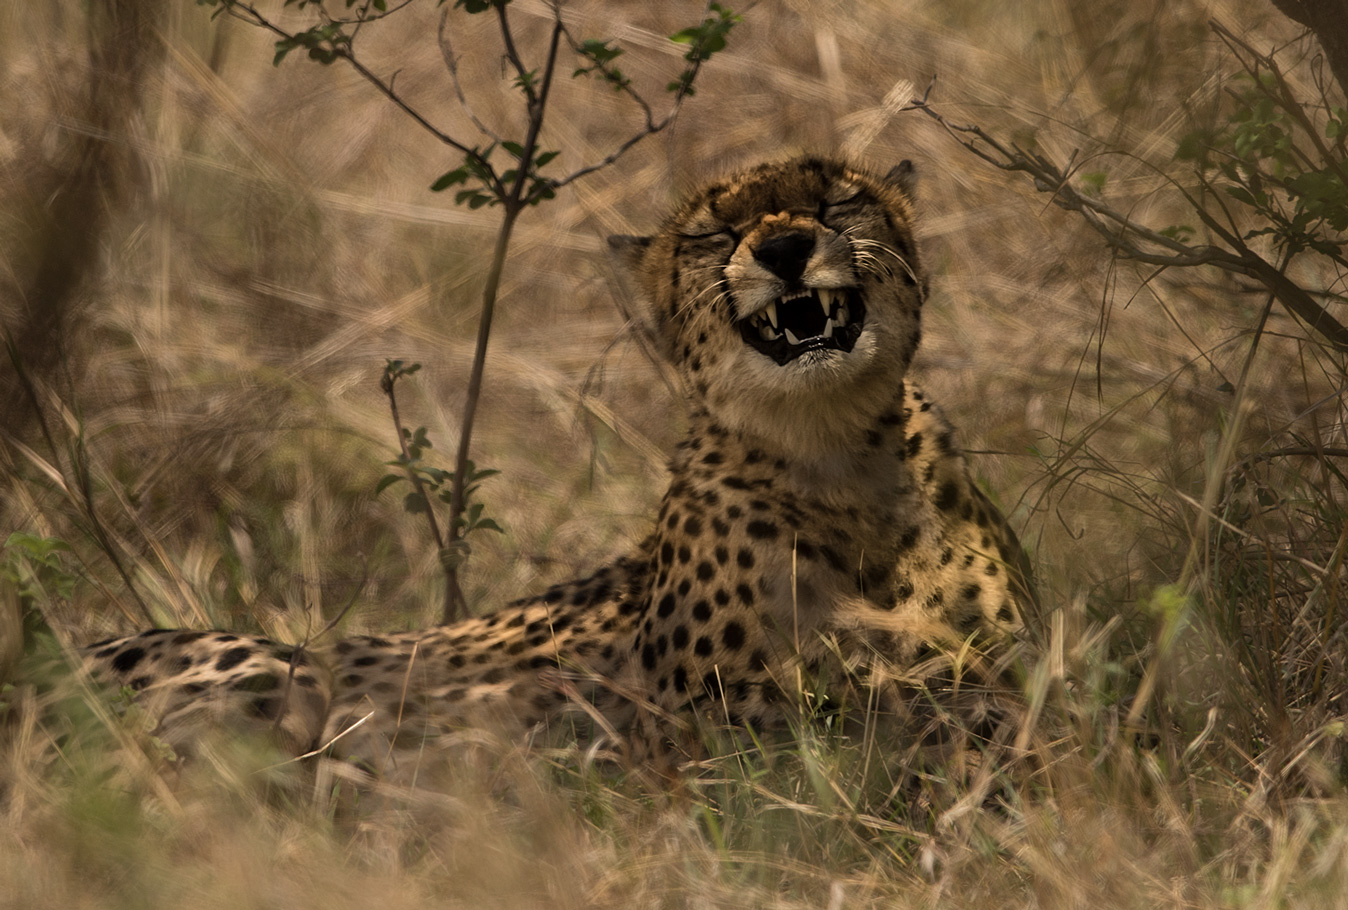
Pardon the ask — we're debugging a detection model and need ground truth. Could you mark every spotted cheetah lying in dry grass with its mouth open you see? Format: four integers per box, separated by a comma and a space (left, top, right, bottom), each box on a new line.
76, 156, 1033, 772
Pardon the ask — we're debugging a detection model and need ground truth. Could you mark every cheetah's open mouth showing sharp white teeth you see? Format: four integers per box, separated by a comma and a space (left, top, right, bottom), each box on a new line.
740, 287, 865, 364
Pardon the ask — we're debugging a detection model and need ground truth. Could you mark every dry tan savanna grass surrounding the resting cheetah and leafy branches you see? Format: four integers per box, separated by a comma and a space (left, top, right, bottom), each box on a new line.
0, 0, 1348, 909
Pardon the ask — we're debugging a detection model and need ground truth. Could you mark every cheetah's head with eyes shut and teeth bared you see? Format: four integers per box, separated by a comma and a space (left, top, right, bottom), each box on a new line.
609, 158, 925, 452
